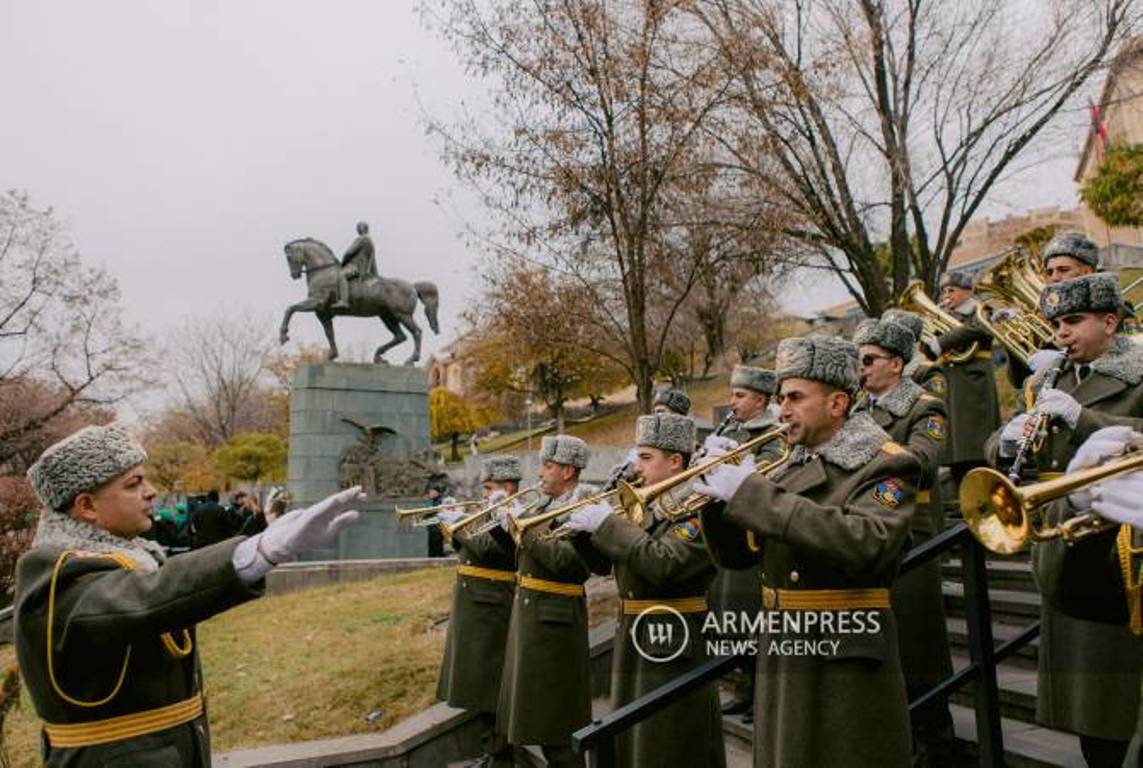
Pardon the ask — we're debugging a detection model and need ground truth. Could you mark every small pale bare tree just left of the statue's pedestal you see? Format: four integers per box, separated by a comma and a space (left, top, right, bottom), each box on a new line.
169, 310, 278, 448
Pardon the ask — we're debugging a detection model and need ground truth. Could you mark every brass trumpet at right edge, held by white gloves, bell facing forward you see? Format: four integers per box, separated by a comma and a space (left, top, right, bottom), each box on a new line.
959, 450, 1143, 554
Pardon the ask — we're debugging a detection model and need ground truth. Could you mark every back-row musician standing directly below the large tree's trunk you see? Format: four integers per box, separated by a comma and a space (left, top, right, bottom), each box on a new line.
930, 272, 1000, 486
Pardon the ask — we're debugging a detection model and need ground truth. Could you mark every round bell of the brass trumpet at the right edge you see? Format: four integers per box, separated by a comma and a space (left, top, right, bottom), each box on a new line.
959, 467, 1033, 554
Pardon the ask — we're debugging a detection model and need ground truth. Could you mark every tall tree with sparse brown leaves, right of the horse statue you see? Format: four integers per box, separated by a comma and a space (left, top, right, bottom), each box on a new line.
424, 0, 754, 409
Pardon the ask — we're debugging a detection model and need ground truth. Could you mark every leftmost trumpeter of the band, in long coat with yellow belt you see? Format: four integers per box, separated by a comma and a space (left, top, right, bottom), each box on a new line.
437, 456, 520, 766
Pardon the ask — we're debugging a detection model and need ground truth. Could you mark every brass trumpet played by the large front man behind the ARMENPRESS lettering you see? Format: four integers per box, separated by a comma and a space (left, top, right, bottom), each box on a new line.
617, 424, 790, 526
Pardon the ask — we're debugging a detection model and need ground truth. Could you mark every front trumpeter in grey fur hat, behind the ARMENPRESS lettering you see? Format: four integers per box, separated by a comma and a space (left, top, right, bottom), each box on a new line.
695, 336, 921, 768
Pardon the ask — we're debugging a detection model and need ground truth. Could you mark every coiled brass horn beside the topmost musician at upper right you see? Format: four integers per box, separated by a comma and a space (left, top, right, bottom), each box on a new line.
976, 248, 1055, 365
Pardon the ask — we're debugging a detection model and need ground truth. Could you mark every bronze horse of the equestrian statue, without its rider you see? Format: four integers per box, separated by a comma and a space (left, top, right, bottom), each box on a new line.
279, 238, 440, 366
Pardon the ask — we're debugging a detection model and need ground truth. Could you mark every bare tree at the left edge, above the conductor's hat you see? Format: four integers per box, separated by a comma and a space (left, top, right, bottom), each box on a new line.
0, 191, 150, 471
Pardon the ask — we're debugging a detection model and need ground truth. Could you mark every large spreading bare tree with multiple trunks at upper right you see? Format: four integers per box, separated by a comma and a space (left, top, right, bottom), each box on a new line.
692, 0, 1138, 313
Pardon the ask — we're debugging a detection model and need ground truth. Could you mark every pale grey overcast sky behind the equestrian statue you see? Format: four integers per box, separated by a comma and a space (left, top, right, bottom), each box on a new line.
0, 0, 1084, 411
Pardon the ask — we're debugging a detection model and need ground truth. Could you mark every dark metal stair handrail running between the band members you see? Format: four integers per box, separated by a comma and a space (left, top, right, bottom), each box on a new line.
572, 522, 1040, 768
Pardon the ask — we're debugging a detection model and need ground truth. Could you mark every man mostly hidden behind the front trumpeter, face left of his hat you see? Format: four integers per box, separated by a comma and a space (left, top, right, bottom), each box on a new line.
706, 366, 778, 725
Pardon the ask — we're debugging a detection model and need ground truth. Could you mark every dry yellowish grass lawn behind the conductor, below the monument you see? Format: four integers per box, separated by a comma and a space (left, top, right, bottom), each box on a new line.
0, 568, 455, 766
